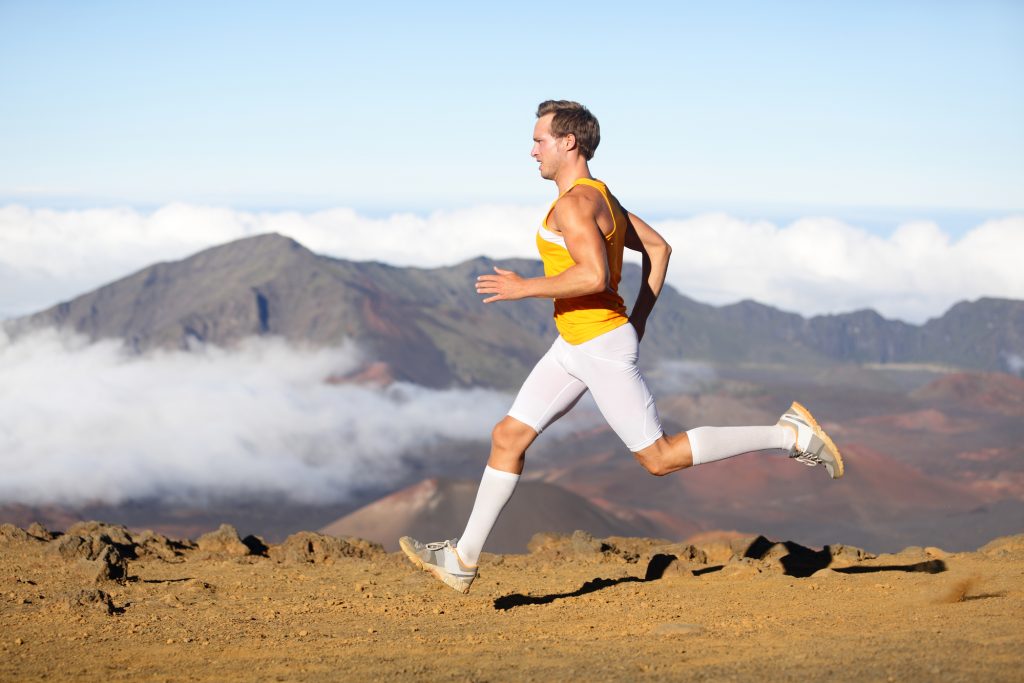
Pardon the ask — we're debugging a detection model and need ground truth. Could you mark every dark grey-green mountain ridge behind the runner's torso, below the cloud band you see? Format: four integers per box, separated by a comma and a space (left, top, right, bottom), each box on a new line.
4, 234, 1024, 388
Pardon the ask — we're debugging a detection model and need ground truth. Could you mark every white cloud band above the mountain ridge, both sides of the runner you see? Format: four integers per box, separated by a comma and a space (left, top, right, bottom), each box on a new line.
0, 204, 1024, 323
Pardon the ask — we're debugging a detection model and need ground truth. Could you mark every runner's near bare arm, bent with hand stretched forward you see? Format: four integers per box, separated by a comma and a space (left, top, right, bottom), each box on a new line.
476, 194, 608, 303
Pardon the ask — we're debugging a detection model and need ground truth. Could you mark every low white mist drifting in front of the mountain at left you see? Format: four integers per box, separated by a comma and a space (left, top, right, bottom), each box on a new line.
0, 330, 520, 504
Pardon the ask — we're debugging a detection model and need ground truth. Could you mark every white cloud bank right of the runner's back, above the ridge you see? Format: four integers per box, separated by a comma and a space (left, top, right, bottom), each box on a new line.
656, 214, 1024, 323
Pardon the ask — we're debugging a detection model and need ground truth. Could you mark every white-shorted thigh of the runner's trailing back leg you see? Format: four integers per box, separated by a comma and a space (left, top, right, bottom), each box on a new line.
567, 325, 664, 453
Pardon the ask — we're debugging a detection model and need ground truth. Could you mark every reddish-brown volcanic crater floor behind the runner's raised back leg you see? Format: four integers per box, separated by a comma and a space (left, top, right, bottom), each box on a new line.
516, 374, 1024, 551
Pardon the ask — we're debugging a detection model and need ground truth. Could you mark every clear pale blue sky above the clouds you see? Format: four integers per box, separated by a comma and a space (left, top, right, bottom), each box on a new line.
0, 0, 1024, 227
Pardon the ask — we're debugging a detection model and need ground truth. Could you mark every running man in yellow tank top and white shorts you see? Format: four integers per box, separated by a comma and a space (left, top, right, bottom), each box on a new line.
399, 100, 843, 593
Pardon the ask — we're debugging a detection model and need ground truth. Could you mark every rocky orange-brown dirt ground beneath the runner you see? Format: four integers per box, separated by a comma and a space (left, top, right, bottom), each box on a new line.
0, 523, 1024, 681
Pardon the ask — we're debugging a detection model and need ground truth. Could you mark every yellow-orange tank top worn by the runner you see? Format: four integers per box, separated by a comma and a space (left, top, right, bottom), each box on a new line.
537, 178, 629, 344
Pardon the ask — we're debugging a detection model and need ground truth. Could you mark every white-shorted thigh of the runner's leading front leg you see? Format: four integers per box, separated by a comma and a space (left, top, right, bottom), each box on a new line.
508, 338, 587, 434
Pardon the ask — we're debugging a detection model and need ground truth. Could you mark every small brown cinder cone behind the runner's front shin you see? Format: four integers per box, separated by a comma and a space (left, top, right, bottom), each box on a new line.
322, 478, 696, 553
